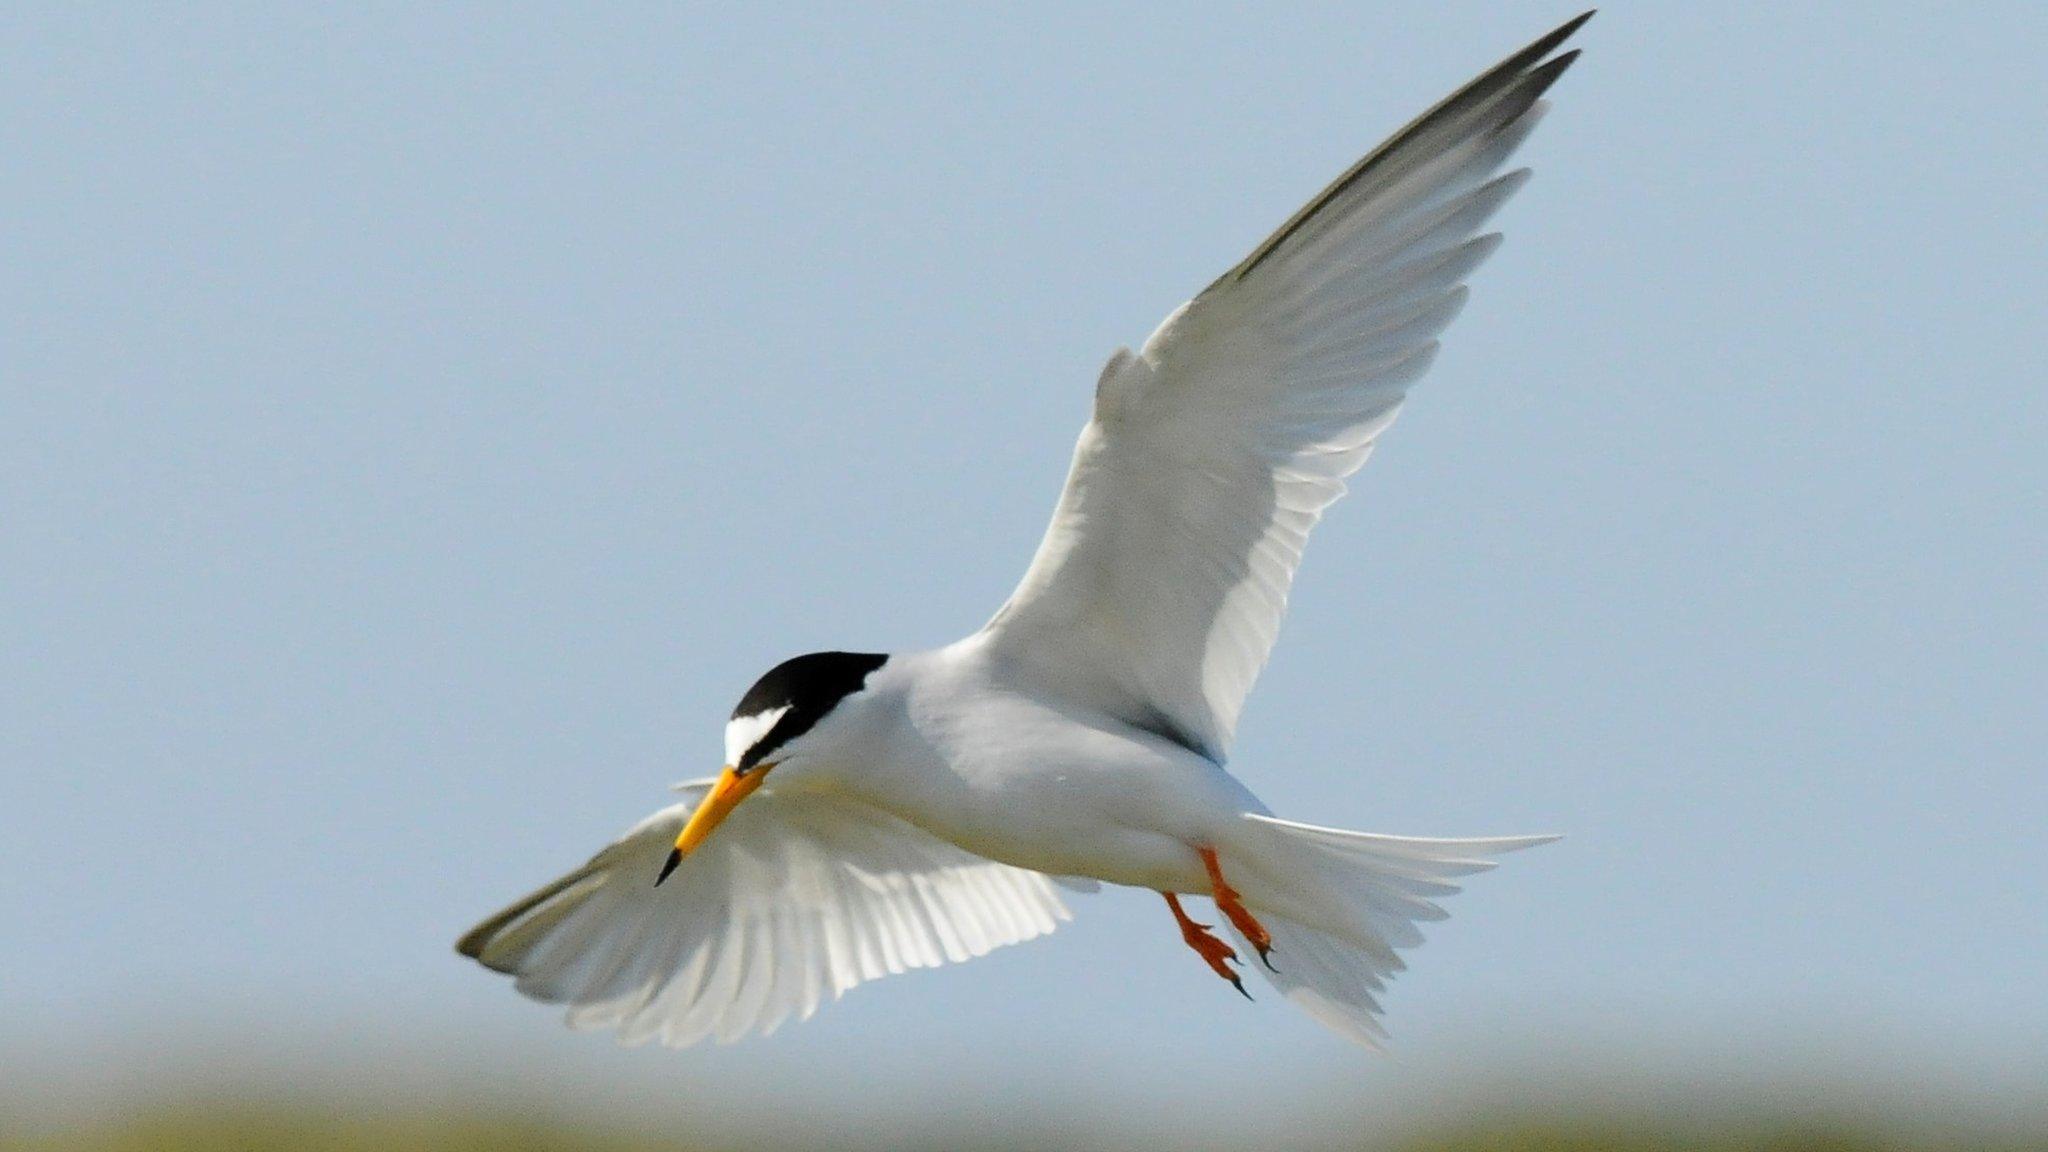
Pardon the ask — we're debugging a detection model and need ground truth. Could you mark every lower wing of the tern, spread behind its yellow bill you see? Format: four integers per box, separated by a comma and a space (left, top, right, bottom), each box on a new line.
455, 781, 1069, 1047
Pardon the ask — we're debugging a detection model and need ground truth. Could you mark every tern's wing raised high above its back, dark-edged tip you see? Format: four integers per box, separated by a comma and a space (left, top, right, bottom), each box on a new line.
985, 12, 1591, 760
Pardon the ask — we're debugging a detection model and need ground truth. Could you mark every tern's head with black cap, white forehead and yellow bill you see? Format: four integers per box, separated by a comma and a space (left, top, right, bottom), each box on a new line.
655, 652, 889, 883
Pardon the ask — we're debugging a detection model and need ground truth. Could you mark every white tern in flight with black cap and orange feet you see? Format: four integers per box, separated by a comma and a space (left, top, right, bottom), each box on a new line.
457, 12, 1593, 1047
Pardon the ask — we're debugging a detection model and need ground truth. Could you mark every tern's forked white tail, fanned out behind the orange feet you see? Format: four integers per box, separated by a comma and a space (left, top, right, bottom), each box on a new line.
1223, 816, 1556, 1047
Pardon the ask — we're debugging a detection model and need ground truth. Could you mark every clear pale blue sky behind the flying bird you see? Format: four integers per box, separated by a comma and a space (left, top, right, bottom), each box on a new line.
0, 4, 2048, 1131
